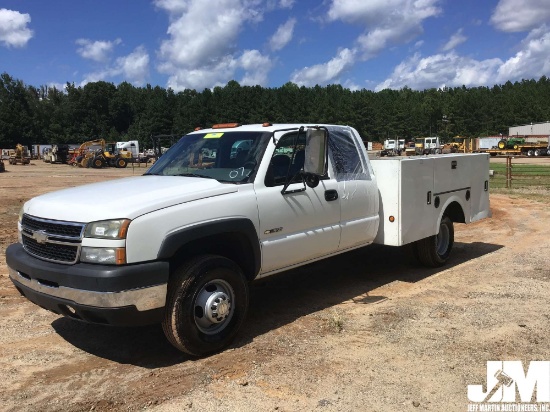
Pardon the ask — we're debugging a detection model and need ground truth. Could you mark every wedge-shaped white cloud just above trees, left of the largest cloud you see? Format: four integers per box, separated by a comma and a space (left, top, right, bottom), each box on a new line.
81, 46, 149, 86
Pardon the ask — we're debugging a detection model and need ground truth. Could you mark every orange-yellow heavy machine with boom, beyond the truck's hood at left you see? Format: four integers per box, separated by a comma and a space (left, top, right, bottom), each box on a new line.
69, 139, 132, 169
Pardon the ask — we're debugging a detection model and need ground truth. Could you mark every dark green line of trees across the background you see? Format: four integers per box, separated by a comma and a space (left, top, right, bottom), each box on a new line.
0, 73, 550, 148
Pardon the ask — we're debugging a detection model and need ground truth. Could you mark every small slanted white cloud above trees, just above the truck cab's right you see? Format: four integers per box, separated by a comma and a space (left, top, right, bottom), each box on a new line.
291, 48, 355, 86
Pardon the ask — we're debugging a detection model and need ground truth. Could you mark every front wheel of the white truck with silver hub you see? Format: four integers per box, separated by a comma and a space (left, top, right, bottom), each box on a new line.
162, 255, 248, 356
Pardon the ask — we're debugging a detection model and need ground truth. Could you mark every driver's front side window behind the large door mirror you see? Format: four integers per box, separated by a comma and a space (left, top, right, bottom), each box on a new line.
265, 133, 305, 187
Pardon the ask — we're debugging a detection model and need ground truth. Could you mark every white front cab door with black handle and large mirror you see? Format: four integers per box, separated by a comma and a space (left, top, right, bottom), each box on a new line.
254, 132, 340, 276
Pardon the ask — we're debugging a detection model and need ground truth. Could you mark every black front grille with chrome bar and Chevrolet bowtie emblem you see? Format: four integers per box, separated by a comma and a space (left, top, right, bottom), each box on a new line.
21, 215, 85, 264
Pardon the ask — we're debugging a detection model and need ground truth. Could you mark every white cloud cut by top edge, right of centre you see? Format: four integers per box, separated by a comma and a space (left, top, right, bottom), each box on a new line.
327, 0, 441, 60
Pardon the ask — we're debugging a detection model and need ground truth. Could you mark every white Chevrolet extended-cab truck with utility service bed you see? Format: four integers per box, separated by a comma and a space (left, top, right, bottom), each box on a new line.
6, 123, 490, 356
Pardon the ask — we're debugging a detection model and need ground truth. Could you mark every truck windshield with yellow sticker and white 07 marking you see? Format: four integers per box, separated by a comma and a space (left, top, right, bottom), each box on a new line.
146, 131, 271, 183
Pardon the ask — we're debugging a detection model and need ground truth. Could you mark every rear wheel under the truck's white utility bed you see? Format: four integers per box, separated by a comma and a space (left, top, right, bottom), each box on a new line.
416, 216, 454, 267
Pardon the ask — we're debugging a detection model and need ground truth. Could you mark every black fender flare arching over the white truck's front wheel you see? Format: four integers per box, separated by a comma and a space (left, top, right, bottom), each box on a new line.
157, 218, 262, 280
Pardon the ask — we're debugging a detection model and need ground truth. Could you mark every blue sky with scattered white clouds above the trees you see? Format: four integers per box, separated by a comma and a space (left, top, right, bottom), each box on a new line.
0, 0, 550, 91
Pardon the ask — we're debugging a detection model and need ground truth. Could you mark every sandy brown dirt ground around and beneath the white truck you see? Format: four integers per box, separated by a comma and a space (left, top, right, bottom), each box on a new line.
0, 161, 550, 412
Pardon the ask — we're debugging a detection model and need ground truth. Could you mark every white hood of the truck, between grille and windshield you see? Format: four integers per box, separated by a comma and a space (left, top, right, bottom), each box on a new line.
25, 176, 239, 223
